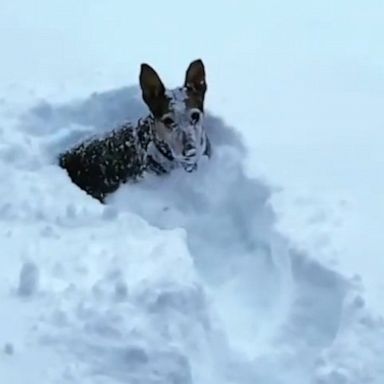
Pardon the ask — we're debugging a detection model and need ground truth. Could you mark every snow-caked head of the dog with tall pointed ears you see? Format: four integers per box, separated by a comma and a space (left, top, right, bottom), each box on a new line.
140, 60, 208, 172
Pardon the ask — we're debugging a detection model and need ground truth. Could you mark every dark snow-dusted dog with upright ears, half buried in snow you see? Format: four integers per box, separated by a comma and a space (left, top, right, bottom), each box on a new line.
59, 59, 211, 203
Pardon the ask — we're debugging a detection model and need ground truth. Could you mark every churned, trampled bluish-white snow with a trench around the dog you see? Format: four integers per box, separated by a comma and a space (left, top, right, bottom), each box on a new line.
0, 88, 384, 384
